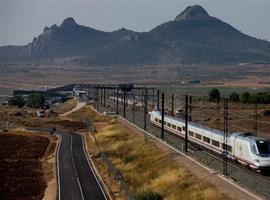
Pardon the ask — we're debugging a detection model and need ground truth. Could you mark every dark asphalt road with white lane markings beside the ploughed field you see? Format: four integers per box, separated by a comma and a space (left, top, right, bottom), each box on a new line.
56, 132, 106, 200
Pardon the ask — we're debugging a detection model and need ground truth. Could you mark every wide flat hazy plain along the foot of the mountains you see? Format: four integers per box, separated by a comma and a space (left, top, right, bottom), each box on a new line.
0, 63, 270, 94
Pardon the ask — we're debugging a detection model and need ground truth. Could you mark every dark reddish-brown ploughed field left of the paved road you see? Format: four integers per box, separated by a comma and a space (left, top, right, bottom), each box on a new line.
0, 131, 56, 200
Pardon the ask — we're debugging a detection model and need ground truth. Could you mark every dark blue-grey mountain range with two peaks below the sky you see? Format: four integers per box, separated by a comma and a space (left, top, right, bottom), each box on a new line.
0, 5, 270, 65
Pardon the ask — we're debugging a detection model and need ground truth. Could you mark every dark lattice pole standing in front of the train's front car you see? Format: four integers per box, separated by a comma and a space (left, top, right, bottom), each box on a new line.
223, 98, 228, 175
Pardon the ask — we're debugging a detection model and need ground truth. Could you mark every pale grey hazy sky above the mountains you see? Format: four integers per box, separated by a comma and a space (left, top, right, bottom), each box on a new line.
0, 0, 270, 46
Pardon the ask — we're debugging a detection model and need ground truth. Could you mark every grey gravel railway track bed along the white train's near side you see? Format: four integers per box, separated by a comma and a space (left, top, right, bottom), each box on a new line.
95, 101, 270, 199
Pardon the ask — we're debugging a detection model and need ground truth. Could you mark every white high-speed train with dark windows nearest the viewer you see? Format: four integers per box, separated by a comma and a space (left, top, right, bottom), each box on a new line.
149, 110, 270, 172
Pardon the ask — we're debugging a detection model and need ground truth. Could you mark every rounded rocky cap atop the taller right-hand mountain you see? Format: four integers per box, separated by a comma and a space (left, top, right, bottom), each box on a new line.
175, 5, 210, 21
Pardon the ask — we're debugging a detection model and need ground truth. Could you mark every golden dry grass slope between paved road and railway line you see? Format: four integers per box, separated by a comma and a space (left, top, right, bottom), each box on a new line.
84, 111, 228, 200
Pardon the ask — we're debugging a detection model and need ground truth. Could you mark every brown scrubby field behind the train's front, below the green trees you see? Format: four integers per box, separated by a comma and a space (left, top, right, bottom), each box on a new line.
193, 103, 270, 138
